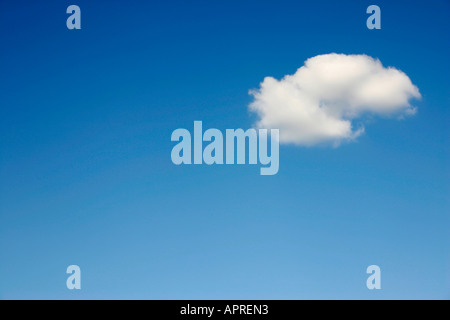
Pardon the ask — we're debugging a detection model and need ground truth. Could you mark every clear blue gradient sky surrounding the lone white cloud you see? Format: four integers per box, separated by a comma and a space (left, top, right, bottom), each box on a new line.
0, 0, 450, 299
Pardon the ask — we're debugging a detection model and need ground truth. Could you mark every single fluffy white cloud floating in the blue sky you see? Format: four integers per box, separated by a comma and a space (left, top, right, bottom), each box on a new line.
249, 53, 421, 146
